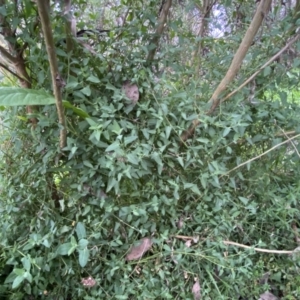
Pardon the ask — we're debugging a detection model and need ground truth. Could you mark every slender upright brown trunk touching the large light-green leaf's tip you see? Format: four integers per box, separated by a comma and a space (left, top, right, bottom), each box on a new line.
37, 1, 67, 149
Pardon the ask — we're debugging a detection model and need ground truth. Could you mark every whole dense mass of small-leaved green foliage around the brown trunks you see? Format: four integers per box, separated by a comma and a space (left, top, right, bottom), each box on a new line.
0, 1, 300, 299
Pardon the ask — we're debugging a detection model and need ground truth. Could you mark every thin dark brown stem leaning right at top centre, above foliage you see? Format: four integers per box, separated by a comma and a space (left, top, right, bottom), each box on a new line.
147, 0, 172, 63
